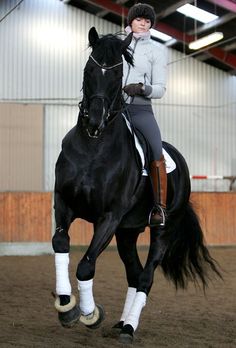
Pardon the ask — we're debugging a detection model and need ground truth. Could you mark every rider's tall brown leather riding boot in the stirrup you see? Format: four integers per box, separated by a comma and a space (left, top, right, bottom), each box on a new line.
149, 155, 167, 227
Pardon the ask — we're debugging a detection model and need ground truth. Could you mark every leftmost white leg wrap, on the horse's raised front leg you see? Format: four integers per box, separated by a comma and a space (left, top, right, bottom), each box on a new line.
55, 253, 71, 296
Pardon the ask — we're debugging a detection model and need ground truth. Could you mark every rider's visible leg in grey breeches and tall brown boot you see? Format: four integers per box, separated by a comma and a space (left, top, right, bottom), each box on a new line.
127, 104, 167, 227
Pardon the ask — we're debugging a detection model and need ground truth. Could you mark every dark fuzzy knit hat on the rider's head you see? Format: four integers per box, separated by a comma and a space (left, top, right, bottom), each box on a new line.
127, 3, 156, 27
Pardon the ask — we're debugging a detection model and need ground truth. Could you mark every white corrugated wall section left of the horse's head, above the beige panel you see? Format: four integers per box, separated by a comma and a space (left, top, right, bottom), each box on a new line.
0, 0, 117, 99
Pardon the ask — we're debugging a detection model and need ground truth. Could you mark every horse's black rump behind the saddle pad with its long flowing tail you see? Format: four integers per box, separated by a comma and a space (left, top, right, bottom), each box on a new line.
161, 143, 222, 289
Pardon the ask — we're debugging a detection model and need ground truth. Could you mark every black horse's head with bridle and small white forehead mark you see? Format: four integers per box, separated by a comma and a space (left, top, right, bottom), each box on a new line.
81, 27, 133, 138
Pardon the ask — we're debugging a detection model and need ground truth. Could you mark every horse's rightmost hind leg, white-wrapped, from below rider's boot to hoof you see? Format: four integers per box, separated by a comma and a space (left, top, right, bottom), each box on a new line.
120, 229, 166, 343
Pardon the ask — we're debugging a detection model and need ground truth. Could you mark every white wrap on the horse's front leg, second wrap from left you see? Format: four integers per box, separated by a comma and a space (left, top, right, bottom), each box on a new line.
78, 279, 95, 315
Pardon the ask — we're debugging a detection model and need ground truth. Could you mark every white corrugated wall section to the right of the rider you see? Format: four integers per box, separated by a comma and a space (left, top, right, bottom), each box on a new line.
153, 50, 236, 190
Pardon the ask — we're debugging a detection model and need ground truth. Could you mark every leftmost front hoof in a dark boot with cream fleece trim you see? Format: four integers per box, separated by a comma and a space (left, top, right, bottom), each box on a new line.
55, 295, 81, 328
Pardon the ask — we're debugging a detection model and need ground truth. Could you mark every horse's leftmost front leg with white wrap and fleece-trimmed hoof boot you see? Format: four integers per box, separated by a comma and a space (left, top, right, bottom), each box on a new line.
52, 194, 80, 327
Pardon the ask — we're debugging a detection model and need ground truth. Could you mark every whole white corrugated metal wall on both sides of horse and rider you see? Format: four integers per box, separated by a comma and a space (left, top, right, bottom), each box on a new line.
0, 0, 236, 190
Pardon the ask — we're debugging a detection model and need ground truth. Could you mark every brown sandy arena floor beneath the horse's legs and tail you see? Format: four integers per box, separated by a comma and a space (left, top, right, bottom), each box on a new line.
0, 247, 236, 348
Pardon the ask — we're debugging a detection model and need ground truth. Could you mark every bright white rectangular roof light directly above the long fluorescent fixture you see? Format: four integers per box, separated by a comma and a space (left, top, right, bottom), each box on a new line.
176, 4, 219, 23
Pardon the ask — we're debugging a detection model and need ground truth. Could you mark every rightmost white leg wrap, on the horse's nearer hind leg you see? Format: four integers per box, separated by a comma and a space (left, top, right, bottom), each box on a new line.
124, 291, 147, 331
